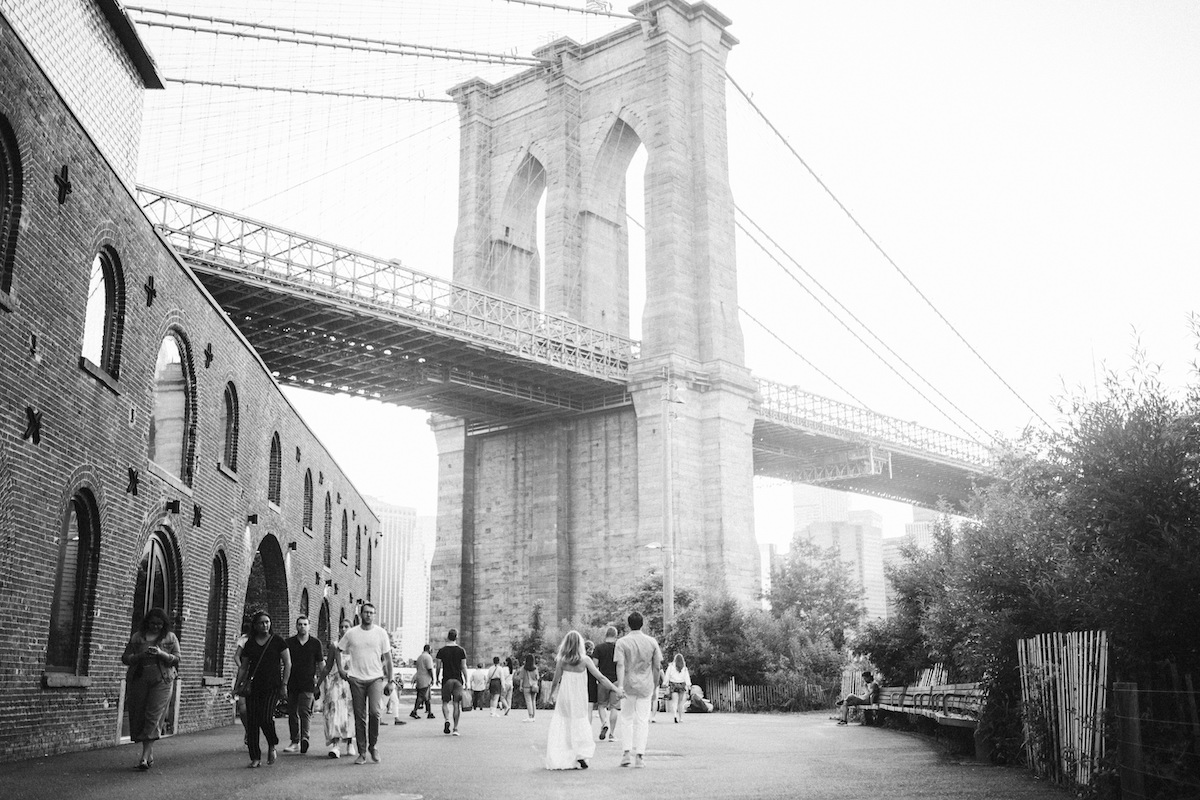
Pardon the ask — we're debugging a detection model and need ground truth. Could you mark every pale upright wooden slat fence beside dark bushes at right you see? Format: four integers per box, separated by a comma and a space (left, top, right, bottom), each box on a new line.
1016, 631, 1109, 787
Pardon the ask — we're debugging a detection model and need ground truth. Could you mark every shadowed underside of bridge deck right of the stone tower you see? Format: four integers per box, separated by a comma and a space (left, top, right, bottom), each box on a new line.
754, 419, 985, 511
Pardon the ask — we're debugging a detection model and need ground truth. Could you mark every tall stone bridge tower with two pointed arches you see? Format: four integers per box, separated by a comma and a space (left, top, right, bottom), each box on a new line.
430, 0, 760, 661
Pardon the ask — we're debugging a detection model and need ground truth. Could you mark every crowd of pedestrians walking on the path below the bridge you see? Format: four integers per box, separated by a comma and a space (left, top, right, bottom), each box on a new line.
121, 603, 712, 770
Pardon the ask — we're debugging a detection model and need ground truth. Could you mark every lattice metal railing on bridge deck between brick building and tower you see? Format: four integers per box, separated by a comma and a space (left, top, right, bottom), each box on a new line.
138, 187, 638, 383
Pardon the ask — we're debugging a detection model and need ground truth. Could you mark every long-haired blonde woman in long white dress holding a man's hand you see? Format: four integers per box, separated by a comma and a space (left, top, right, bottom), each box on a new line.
546, 631, 625, 770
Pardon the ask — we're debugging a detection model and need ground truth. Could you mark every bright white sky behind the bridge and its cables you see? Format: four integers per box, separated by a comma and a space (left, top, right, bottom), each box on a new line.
133, 0, 1200, 543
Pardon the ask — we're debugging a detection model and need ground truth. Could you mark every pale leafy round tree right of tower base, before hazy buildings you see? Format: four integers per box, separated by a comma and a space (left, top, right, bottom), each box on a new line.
767, 535, 866, 650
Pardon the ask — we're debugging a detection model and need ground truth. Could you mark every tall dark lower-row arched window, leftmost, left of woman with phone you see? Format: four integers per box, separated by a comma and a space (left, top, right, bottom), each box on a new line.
46, 489, 100, 675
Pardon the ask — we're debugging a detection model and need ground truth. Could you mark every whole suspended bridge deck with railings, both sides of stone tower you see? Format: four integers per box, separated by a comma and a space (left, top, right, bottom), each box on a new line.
138, 188, 991, 507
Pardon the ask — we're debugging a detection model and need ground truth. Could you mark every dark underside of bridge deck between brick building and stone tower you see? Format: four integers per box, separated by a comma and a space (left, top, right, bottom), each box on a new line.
194, 266, 629, 423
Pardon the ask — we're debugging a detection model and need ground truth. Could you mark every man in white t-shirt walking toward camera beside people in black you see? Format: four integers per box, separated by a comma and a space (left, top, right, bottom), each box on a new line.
334, 603, 391, 764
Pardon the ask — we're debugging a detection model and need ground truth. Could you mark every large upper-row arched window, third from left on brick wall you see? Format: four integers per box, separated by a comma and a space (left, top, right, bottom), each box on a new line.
146, 332, 196, 486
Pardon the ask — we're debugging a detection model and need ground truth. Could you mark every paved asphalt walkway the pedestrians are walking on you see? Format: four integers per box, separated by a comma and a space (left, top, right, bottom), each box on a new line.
0, 709, 1068, 800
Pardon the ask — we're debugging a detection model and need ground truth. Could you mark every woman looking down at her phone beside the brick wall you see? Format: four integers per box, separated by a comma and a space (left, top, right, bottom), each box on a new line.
121, 608, 179, 770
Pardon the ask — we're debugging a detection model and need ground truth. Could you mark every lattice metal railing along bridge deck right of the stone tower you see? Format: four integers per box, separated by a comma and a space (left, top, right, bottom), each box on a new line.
758, 379, 992, 468
